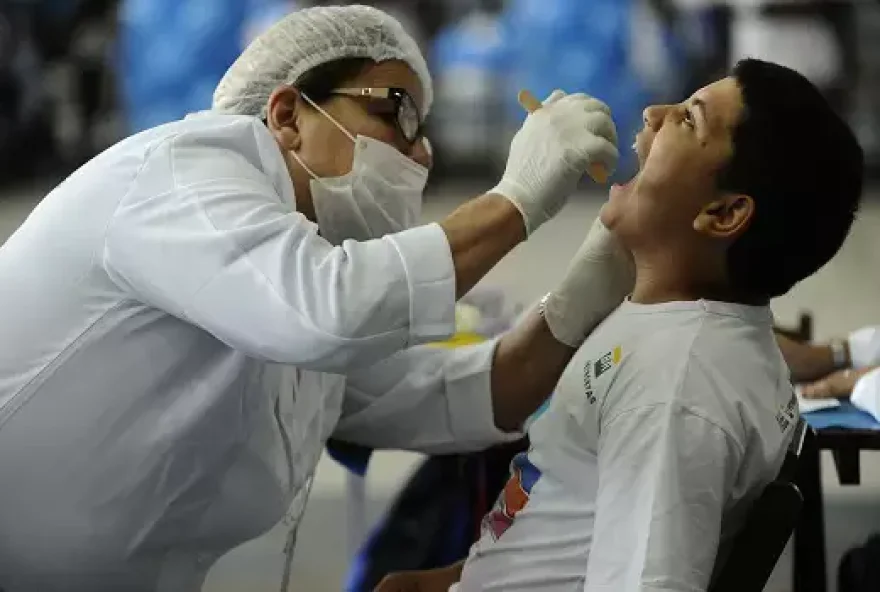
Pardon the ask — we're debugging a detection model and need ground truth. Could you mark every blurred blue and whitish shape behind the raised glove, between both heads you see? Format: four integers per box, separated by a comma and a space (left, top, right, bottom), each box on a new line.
430, 0, 653, 179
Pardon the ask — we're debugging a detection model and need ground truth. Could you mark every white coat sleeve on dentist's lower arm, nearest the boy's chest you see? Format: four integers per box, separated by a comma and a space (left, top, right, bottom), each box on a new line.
334, 341, 522, 454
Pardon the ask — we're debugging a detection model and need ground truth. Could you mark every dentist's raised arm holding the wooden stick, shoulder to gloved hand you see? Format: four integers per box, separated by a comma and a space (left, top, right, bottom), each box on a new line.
102, 96, 617, 373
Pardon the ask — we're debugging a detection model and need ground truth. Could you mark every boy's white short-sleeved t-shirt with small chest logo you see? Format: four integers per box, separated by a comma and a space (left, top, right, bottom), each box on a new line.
453, 301, 798, 592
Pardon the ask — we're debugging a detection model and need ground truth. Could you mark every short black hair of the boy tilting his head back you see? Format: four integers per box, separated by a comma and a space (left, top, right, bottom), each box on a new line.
718, 59, 864, 298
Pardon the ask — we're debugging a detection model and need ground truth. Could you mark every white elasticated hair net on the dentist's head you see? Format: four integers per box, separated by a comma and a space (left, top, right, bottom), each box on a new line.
212, 4, 434, 117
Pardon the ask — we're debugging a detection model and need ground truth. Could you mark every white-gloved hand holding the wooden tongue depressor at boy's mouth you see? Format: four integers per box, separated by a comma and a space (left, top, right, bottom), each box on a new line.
489, 90, 620, 234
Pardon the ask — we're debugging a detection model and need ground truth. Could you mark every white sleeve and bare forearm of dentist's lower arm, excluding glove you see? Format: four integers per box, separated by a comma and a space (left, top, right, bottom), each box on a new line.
333, 311, 575, 454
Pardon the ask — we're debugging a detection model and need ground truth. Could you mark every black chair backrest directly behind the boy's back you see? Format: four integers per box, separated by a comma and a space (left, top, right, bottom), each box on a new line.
709, 419, 816, 592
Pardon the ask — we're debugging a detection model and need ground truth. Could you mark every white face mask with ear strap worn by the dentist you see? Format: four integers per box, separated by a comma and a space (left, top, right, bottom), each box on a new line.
292, 95, 428, 245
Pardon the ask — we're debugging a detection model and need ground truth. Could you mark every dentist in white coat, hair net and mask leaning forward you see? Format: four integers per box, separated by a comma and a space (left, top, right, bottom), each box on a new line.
0, 6, 631, 592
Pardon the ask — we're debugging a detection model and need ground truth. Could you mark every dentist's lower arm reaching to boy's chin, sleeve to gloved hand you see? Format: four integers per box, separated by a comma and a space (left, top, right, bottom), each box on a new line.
334, 221, 634, 454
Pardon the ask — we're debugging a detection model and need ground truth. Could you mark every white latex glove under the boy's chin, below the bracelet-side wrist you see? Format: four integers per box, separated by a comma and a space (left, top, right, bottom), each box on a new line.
543, 218, 636, 347
